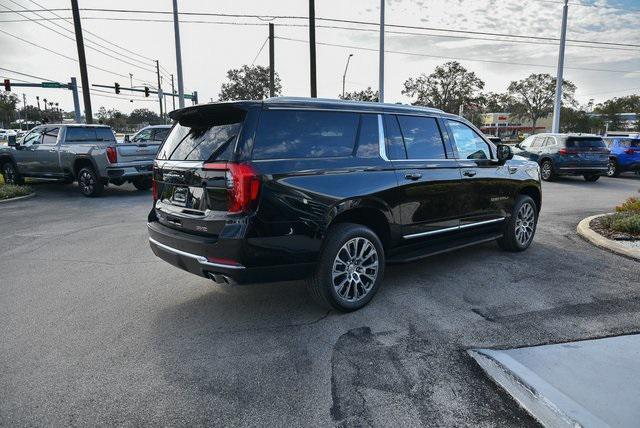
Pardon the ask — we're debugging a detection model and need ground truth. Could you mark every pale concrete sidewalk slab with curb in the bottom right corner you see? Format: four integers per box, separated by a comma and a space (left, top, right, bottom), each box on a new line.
469, 334, 640, 427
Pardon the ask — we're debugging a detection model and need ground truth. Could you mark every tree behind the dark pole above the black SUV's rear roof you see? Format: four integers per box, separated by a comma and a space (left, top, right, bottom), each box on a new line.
218, 65, 282, 101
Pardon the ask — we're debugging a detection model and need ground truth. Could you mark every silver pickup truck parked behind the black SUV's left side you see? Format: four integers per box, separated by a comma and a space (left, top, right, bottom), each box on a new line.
0, 124, 161, 196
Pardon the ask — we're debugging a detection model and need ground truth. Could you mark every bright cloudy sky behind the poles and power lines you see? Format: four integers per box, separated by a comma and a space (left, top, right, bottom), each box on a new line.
0, 0, 640, 111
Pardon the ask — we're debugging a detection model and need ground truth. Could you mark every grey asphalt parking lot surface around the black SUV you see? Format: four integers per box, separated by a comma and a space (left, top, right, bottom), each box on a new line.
0, 176, 640, 426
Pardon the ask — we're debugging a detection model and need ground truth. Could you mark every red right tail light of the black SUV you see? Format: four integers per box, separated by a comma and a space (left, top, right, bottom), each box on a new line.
204, 162, 260, 213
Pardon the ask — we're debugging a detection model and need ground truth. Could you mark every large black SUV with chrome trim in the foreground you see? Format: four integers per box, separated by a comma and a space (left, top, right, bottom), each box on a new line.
148, 98, 541, 311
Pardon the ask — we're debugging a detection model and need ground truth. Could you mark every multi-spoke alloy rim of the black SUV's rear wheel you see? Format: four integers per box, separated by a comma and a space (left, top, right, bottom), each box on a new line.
331, 237, 378, 302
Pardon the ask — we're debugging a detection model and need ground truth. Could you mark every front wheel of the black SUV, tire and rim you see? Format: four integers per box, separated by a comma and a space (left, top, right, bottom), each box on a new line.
498, 195, 538, 252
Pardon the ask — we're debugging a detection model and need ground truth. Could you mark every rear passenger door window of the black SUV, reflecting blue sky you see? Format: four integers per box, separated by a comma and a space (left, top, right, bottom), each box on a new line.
398, 116, 447, 159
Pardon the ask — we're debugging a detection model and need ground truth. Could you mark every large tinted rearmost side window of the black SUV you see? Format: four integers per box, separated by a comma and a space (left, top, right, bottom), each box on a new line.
253, 110, 359, 159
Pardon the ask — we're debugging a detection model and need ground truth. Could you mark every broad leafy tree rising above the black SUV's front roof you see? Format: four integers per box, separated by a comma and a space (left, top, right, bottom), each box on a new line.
402, 61, 484, 113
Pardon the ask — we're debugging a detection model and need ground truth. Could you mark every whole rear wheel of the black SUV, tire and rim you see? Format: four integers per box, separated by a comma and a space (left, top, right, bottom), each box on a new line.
307, 223, 385, 312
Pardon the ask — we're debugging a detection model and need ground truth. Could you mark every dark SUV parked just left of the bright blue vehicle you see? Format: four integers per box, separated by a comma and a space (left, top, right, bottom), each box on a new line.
515, 133, 609, 182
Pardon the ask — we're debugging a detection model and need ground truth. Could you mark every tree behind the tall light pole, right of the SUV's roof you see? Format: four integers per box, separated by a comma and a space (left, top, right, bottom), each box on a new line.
507, 73, 576, 133
